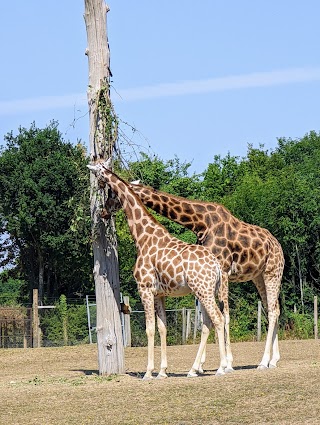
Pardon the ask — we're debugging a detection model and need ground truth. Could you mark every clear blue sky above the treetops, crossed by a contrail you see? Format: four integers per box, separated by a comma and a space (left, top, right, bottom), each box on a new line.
0, 0, 320, 172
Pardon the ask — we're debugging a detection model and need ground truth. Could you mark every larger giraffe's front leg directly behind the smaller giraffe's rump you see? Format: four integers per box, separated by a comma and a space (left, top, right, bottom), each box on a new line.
218, 273, 234, 373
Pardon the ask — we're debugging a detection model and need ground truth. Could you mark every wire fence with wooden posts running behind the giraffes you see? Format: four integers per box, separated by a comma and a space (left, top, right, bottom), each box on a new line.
0, 296, 319, 348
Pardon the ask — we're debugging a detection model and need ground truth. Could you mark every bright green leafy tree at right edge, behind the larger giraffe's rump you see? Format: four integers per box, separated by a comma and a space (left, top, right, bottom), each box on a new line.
222, 132, 320, 314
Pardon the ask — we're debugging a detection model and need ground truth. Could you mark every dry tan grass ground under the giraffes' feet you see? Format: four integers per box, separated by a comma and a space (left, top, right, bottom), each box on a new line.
0, 340, 320, 425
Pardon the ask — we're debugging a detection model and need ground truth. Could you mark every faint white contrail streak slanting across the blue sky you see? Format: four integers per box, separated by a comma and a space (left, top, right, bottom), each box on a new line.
0, 68, 320, 115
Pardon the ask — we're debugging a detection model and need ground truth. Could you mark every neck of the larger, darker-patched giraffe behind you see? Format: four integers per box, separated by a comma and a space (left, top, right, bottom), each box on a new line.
130, 184, 221, 239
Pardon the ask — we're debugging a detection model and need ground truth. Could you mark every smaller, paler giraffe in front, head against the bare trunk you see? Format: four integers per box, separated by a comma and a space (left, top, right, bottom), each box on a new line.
88, 161, 227, 379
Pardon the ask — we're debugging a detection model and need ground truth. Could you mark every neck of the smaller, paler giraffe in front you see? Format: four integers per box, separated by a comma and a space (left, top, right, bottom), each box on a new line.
103, 168, 167, 249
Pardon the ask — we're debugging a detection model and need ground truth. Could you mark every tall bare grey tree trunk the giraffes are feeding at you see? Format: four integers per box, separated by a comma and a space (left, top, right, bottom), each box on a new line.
84, 0, 124, 375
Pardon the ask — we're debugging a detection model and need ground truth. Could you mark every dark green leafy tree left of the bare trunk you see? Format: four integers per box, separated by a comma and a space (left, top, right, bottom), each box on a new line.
0, 122, 92, 300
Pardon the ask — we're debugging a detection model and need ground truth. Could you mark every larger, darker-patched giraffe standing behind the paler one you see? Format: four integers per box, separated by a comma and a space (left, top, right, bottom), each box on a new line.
130, 182, 284, 372
